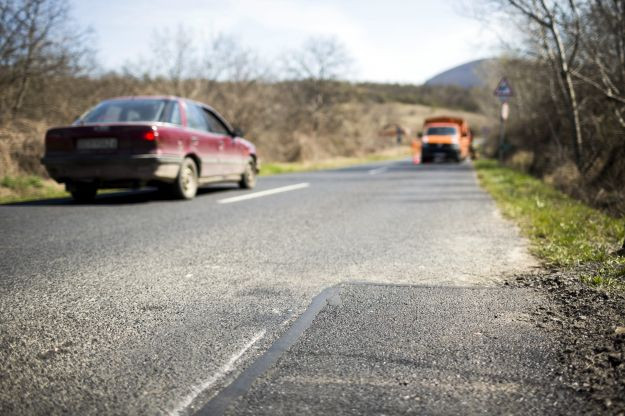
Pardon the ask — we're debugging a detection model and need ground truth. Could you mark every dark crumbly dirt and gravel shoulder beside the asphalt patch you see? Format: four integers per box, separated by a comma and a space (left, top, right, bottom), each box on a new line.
509, 265, 625, 415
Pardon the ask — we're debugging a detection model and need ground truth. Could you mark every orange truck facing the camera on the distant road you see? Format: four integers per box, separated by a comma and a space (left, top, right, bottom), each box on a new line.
412, 117, 473, 163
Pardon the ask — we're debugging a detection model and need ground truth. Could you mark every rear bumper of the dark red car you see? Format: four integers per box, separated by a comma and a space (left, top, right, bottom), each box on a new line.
41, 154, 183, 184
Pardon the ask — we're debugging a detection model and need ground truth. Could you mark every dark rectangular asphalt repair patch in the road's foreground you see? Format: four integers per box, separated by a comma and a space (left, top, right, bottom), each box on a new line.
226, 284, 588, 415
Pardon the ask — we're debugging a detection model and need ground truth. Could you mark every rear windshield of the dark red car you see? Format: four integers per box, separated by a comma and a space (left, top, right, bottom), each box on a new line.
79, 99, 173, 123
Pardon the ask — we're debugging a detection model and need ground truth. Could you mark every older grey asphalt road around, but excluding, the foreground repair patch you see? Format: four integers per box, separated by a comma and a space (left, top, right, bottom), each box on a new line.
0, 161, 556, 414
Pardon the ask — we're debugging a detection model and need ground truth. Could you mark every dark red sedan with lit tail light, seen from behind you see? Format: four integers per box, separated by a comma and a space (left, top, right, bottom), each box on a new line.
42, 96, 259, 202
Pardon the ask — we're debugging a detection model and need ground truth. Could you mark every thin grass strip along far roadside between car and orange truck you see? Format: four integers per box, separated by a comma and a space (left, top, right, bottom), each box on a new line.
260, 147, 410, 176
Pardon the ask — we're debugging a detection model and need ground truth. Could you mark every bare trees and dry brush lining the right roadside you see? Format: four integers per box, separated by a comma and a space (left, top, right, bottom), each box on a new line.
472, 0, 625, 216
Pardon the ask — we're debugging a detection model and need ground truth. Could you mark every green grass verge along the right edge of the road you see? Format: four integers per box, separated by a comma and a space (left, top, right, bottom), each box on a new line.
475, 160, 625, 289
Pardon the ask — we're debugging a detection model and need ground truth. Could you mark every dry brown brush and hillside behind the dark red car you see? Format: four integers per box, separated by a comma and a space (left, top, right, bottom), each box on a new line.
0, 75, 489, 177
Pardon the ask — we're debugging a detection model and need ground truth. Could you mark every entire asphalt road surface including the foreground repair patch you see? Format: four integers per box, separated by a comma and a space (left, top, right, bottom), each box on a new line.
0, 161, 584, 414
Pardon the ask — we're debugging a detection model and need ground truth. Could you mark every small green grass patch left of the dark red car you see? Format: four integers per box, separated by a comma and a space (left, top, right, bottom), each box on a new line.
0, 175, 69, 204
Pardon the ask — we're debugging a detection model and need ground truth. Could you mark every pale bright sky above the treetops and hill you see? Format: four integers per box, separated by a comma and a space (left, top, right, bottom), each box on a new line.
73, 0, 499, 83
